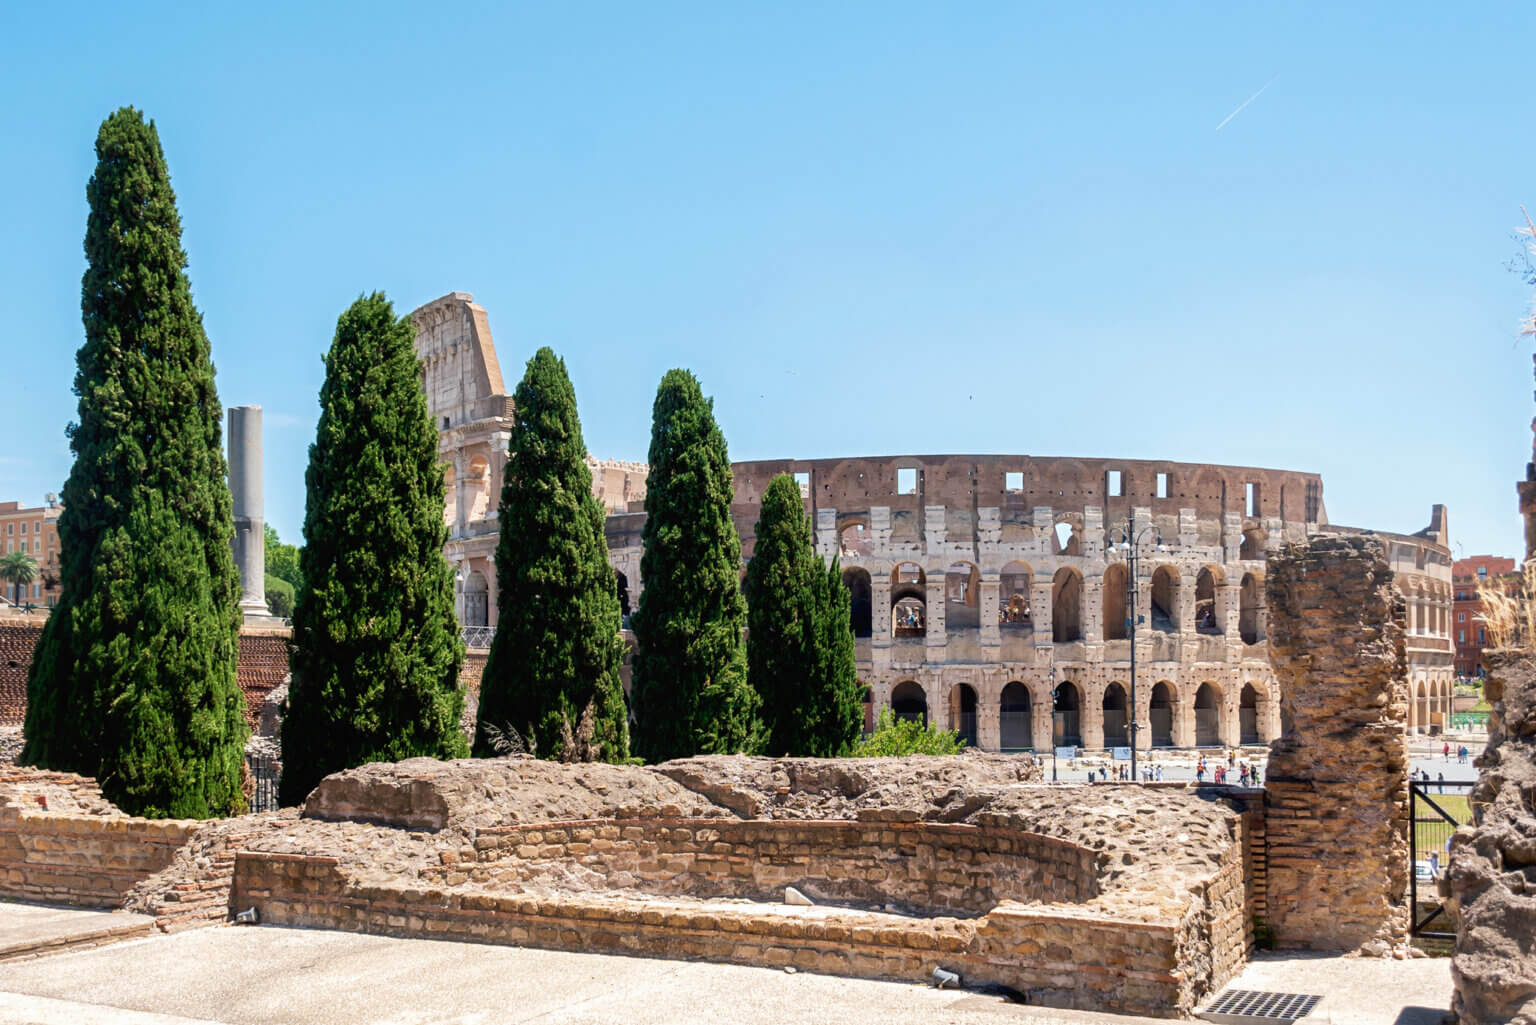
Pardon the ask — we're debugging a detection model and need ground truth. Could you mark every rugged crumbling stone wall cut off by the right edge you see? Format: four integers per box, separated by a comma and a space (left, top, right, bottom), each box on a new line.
1448, 650, 1536, 1025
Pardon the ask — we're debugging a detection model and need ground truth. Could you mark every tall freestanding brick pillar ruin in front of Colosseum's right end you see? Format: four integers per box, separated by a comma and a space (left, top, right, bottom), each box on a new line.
1266, 535, 1409, 954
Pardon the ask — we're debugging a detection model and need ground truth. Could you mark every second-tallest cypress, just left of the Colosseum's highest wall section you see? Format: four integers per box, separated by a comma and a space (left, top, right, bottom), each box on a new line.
278, 292, 468, 805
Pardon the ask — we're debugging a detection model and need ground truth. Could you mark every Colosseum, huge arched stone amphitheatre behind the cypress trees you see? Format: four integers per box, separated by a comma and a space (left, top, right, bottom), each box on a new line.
413, 292, 1453, 751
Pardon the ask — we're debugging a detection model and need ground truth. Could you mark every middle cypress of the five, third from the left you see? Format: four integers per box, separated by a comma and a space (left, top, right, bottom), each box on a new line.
475, 347, 630, 762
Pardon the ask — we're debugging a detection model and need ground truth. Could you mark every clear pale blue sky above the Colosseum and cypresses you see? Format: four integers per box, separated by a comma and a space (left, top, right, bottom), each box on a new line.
0, 0, 1536, 556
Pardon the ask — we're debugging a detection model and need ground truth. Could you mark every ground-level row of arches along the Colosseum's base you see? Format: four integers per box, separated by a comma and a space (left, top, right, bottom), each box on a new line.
891, 679, 1273, 751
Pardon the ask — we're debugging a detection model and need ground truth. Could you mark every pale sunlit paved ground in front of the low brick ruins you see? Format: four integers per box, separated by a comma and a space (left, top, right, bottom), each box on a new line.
0, 904, 1450, 1025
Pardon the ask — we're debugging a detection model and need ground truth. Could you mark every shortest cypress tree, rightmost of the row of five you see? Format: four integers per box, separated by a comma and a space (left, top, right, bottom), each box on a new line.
746, 473, 863, 758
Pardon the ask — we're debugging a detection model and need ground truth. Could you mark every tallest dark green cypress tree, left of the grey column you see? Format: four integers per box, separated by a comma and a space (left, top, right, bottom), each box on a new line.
22, 108, 247, 818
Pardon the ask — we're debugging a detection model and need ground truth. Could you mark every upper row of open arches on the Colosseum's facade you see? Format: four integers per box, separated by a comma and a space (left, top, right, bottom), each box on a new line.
843, 562, 1264, 644
